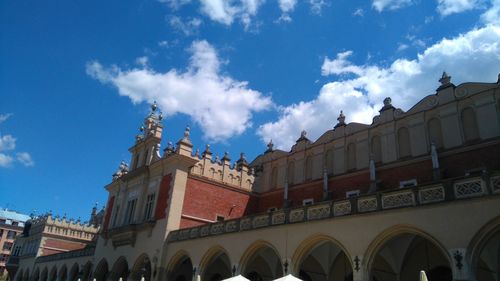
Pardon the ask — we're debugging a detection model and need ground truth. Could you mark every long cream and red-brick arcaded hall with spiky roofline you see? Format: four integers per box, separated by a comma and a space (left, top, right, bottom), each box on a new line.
6, 73, 500, 281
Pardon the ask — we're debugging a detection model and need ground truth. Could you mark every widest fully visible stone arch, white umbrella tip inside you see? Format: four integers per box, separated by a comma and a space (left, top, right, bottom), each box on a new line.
363, 225, 453, 281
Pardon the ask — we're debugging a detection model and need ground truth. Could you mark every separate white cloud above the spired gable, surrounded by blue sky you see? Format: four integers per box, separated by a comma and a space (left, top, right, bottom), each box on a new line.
87, 41, 272, 141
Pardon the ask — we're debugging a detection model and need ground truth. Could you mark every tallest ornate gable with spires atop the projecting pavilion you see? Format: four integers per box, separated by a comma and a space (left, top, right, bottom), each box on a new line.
129, 101, 163, 170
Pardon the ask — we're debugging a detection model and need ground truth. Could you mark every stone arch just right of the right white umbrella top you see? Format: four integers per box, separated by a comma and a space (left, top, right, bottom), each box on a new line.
292, 234, 353, 281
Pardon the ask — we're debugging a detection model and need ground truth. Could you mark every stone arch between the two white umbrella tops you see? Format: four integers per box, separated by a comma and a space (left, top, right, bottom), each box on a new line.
240, 240, 283, 281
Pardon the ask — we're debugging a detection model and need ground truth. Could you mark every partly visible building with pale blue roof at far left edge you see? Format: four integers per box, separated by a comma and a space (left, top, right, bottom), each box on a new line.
0, 209, 30, 275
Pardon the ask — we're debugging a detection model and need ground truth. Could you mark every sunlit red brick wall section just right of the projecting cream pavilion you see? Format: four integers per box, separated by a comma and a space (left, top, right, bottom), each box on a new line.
180, 177, 255, 228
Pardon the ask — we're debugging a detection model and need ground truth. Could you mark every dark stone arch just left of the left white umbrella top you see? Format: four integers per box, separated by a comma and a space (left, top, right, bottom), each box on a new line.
199, 245, 233, 281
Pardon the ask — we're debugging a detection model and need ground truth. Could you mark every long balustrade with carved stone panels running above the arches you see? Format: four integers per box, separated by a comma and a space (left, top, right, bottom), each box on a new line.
168, 175, 500, 242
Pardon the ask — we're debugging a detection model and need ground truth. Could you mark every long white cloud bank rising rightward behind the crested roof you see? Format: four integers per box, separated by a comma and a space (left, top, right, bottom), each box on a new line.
257, 25, 500, 150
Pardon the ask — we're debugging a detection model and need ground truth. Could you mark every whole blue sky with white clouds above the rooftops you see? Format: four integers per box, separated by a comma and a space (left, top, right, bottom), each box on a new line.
0, 0, 500, 220
